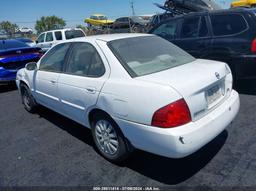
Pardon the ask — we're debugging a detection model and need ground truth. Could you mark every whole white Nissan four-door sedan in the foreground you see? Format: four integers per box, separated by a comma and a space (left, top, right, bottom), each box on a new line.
16, 34, 240, 162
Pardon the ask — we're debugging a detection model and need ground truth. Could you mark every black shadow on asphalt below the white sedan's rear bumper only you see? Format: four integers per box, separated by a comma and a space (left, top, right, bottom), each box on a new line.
126, 130, 228, 185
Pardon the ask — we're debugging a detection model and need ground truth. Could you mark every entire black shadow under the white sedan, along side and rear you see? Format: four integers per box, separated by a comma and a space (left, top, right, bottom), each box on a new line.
37, 107, 228, 185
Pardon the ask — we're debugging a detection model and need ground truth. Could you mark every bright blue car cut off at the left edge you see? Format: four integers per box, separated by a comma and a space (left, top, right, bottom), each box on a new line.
0, 40, 41, 84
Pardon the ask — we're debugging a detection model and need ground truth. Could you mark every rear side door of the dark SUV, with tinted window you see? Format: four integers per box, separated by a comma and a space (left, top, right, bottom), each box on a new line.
175, 16, 211, 58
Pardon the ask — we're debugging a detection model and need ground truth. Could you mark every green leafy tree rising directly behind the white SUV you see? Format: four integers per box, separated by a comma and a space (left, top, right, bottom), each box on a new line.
35, 15, 66, 34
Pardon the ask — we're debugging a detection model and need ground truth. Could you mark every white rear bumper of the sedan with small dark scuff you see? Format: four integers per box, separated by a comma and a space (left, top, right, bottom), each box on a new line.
114, 91, 240, 158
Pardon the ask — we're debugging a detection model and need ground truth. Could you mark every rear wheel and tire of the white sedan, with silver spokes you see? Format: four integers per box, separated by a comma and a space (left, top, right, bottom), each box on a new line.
91, 113, 133, 163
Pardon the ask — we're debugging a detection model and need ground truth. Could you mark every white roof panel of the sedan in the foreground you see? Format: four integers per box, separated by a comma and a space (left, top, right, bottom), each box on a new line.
69, 33, 153, 42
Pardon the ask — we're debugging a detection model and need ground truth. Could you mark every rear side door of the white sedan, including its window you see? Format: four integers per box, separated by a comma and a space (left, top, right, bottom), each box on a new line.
58, 42, 108, 124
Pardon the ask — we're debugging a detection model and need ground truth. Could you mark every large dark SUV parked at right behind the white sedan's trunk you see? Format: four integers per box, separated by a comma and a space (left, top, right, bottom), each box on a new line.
150, 9, 256, 90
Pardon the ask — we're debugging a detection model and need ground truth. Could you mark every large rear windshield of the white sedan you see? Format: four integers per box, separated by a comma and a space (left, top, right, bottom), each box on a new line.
108, 36, 195, 77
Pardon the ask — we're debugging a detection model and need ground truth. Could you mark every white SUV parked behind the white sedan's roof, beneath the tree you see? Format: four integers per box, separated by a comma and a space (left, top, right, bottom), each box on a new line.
36, 28, 86, 52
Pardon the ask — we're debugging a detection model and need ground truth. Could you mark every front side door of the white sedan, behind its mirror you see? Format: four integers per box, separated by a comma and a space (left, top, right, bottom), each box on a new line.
34, 43, 70, 112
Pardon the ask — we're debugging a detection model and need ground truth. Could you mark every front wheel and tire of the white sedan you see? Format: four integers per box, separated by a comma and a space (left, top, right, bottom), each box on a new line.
20, 84, 37, 113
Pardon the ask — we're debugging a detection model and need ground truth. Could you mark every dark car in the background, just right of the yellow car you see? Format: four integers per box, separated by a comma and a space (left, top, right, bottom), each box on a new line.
112, 16, 149, 30
